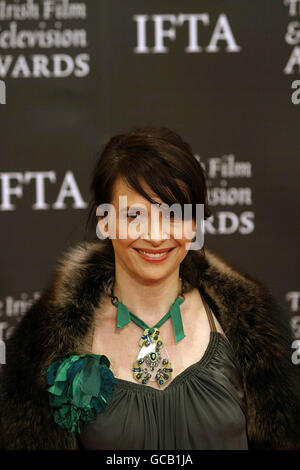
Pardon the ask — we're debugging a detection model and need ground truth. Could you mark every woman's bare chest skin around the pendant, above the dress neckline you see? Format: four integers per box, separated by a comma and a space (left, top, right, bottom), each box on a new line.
92, 307, 210, 389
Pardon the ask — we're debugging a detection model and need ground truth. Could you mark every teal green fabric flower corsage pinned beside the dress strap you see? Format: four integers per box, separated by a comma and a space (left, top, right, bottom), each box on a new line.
43, 354, 117, 432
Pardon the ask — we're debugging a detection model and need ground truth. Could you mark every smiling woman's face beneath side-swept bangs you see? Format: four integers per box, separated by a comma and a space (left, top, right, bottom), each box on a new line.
98, 178, 196, 282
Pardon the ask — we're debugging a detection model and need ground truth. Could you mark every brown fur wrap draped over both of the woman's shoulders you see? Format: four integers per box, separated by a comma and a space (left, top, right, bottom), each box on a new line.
0, 241, 300, 449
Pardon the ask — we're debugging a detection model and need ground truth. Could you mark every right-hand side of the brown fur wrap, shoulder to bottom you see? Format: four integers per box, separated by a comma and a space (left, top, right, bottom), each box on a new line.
202, 246, 300, 449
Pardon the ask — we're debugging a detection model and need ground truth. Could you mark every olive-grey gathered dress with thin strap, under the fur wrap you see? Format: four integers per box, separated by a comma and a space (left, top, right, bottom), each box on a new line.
78, 299, 248, 450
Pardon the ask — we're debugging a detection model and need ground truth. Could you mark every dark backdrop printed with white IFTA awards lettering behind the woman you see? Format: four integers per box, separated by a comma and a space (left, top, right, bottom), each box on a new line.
0, 0, 300, 367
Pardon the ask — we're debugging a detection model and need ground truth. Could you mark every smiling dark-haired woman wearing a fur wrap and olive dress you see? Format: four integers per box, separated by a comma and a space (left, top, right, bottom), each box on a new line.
0, 128, 300, 450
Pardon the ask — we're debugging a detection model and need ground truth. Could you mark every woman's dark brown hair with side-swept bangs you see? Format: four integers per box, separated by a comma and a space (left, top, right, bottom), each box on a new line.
87, 127, 211, 282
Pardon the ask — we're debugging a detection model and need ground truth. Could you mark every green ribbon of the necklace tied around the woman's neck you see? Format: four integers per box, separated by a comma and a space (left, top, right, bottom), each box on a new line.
114, 297, 185, 343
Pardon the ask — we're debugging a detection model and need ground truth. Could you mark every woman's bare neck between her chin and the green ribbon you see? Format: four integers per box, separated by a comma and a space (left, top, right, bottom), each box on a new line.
113, 270, 184, 326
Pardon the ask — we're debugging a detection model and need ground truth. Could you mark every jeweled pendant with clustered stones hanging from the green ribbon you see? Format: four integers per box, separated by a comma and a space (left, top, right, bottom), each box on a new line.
132, 328, 173, 387
